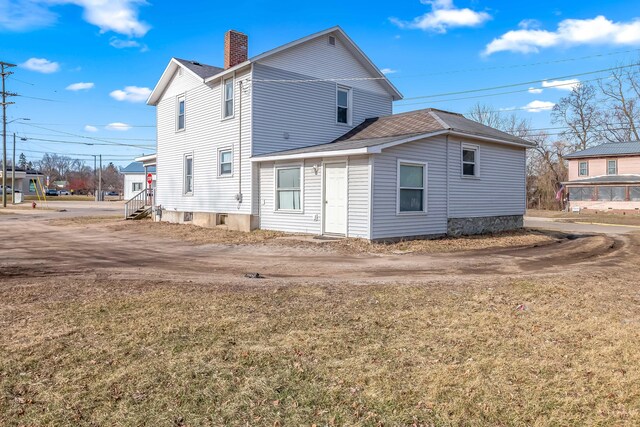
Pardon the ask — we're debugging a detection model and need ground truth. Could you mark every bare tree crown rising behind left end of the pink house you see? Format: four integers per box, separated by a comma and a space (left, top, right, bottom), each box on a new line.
551, 84, 601, 150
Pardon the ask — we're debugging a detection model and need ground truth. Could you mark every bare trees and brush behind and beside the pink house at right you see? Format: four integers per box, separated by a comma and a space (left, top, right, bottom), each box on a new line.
467, 62, 640, 209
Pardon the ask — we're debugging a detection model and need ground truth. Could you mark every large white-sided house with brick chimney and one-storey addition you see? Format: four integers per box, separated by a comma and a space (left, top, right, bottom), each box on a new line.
148, 27, 531, 239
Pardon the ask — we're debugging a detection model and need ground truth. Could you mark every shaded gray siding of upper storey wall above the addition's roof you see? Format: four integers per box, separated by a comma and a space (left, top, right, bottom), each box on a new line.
252, 64, 392, 155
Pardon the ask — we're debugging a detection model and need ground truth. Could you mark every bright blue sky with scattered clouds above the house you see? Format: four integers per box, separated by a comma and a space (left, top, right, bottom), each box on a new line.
0, 0, 640, 165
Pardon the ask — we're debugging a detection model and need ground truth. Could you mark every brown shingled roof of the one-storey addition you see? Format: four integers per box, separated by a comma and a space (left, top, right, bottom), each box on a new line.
255, 108, 533, 159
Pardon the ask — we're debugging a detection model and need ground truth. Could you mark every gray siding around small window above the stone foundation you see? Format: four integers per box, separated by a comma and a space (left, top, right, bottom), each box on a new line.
449, 138, 526, 218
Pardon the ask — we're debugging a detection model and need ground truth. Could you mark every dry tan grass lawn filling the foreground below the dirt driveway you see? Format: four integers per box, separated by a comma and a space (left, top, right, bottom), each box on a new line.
0, 272, 640, 426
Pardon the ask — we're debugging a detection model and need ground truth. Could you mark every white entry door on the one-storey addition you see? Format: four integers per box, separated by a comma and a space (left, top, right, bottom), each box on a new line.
324, 162, 347, 235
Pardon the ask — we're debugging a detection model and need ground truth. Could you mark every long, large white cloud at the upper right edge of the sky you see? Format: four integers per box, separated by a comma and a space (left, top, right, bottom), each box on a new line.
483, 15, 640, 55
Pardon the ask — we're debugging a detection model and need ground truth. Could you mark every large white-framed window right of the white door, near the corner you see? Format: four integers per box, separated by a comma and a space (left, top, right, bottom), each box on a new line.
398, 162, 427, 212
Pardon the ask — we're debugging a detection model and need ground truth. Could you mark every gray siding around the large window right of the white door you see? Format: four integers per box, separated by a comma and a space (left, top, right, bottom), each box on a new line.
371, 137, 447, 239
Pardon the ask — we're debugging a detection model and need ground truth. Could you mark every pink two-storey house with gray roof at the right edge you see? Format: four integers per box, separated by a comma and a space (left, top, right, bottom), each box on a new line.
563, 141, 640, 212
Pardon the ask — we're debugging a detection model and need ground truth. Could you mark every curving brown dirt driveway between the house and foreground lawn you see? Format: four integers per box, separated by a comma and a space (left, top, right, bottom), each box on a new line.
0, 210, 637, 284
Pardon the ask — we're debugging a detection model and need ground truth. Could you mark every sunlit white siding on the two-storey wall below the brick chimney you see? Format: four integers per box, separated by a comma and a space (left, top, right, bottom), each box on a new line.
156, 66, 252, 213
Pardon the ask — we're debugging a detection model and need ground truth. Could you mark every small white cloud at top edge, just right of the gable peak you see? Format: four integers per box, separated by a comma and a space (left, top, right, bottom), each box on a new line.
389, 0, 491, 33
